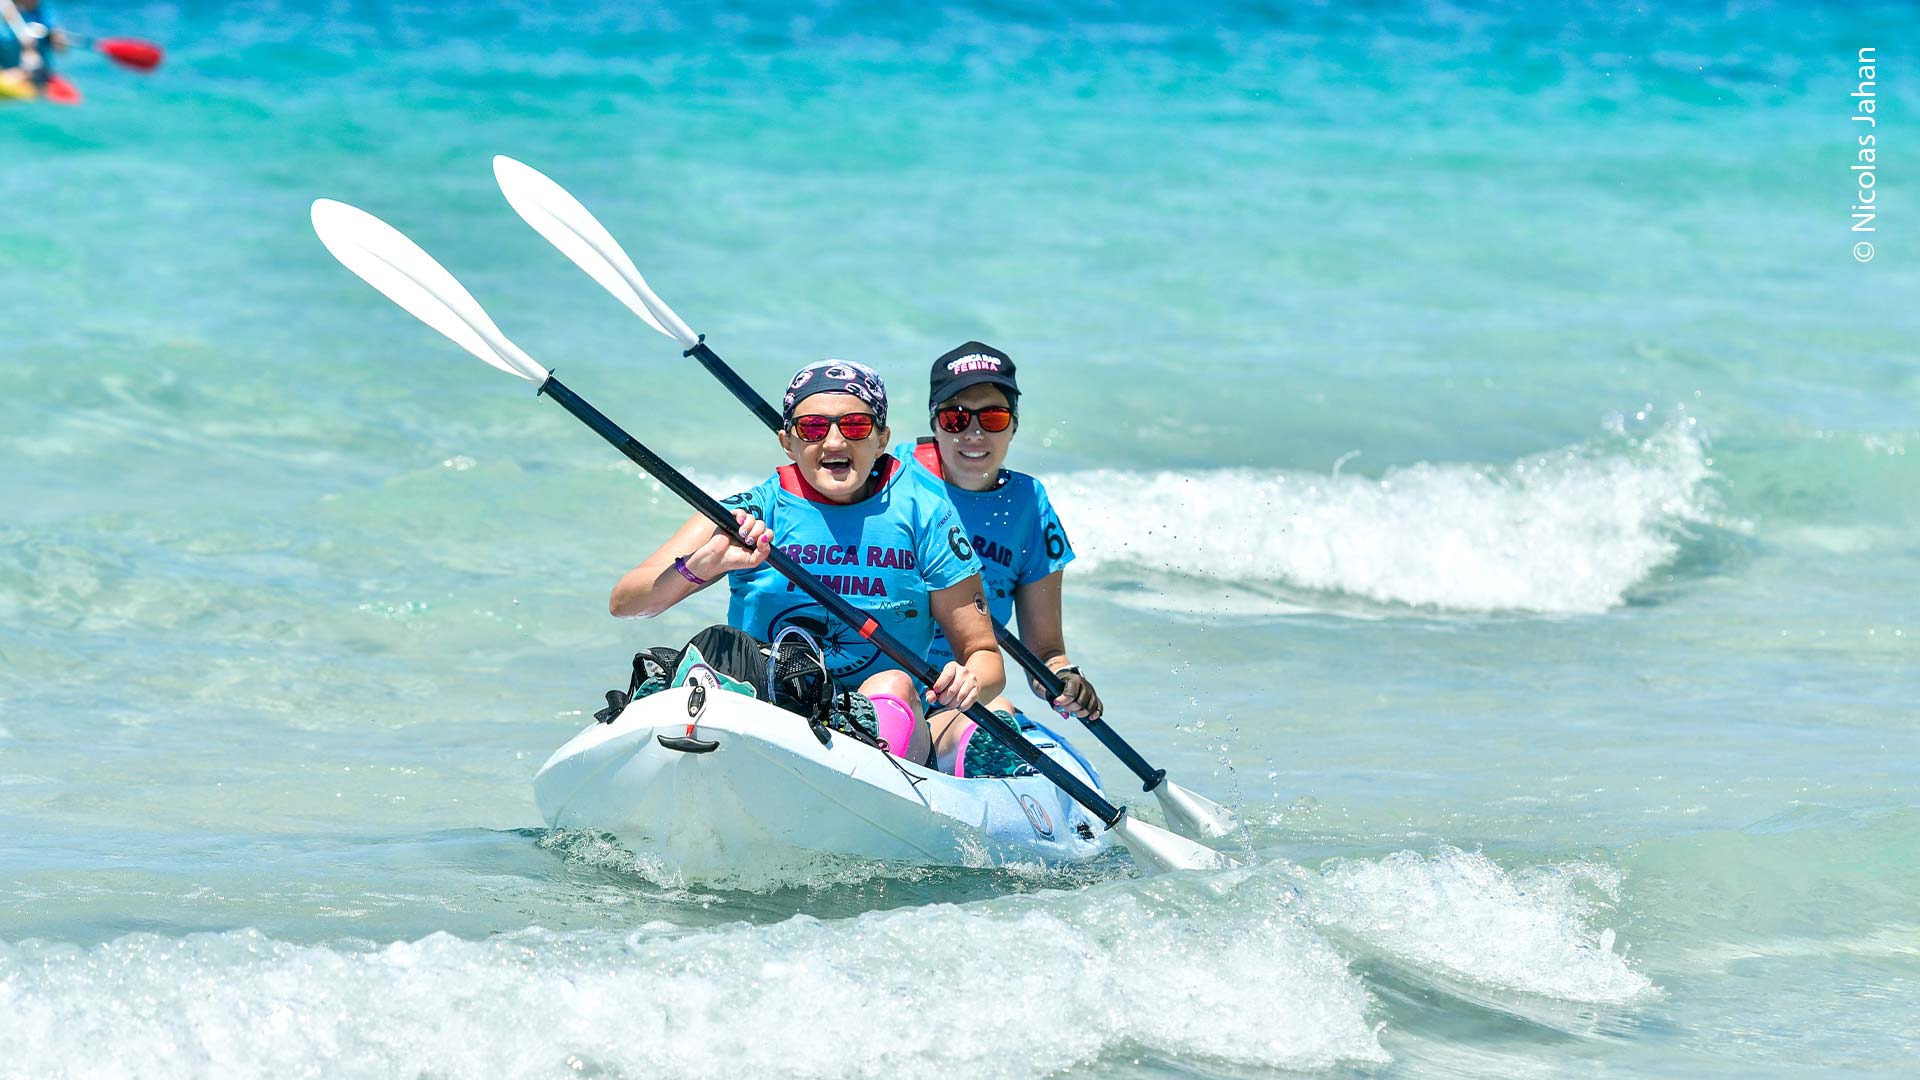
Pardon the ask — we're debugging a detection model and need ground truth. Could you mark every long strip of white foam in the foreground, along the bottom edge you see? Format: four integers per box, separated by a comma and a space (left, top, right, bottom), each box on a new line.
0, 882, 1386, 1076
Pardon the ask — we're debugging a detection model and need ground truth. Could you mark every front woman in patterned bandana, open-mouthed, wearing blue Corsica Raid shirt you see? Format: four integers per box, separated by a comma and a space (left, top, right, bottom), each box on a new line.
609, 359, 1006, 761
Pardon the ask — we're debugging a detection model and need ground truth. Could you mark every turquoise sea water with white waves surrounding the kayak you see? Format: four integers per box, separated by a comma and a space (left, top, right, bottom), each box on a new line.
0, 2, 1920, 1076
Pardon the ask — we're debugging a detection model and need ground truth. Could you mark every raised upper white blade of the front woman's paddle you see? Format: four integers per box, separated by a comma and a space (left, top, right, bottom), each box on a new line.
313, 198, 549, 384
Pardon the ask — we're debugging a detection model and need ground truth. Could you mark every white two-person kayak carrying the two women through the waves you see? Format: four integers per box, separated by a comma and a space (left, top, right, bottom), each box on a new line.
534, 682, 1110, 880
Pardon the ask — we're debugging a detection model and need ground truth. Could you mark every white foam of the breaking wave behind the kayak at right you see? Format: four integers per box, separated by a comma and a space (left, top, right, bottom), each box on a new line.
1046, 417, 1713, 615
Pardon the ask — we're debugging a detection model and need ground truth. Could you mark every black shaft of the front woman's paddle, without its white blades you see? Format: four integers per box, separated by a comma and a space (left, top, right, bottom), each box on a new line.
540, 375, 1125, 828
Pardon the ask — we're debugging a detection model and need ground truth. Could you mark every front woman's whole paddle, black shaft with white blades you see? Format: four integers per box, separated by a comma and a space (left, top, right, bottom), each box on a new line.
313, 200, 1229, 871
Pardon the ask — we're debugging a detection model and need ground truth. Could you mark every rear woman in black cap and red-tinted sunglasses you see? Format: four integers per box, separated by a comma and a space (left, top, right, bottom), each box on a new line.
895, 342, 1100, 776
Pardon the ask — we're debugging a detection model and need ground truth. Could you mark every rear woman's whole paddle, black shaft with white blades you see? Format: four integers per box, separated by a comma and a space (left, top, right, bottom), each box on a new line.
493, 158, 1238, 840
